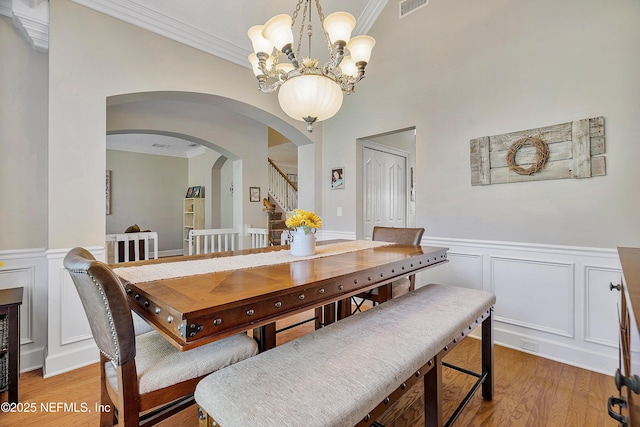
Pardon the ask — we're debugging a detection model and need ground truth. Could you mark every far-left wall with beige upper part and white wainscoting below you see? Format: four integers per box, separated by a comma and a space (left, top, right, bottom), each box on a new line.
0, 16, 48, 371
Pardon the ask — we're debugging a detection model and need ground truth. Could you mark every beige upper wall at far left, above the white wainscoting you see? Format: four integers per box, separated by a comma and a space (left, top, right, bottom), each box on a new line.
0, 16, 48, 250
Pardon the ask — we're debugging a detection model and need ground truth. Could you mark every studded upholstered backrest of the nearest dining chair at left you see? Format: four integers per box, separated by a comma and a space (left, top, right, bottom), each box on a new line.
63, 248, 136, 366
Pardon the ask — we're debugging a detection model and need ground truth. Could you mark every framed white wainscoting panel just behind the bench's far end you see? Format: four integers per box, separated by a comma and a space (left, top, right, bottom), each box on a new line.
490, 257, 574, 337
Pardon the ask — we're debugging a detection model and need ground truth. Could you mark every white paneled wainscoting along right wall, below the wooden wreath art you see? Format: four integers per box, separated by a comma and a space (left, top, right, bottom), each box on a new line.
418, 236, 620, 375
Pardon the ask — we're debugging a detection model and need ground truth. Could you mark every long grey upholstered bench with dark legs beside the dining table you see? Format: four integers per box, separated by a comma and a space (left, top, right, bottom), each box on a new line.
195, 285, 496, 427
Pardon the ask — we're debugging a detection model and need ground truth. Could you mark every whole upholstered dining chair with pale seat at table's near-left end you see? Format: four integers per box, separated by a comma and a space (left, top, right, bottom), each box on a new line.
64, 248, 258, 426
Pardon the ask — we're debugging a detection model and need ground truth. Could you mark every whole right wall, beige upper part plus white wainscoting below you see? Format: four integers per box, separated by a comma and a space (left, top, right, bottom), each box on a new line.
321, 0, 640, 374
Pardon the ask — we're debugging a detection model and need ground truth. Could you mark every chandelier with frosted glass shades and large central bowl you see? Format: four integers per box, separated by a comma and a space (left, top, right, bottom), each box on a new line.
248, 0, 376, 132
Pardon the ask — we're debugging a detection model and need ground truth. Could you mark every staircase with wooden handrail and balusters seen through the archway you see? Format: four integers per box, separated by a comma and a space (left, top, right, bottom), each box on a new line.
263, 159, 298, 245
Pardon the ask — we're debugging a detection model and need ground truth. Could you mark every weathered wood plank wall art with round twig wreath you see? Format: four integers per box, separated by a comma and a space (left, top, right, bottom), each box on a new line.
470, 117, 606, 185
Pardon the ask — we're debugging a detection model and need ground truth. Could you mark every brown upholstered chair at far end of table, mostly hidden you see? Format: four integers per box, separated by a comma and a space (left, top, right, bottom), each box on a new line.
353, 226, 424, 312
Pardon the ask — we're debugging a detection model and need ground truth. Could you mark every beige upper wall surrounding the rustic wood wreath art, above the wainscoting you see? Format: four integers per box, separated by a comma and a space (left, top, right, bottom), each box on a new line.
322, 0, 640, 248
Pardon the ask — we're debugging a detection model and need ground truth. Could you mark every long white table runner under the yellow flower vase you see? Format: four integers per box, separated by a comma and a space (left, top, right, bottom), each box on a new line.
113, 240, 393, 283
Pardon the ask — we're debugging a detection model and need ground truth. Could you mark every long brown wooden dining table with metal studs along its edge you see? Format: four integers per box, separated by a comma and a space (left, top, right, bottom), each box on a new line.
112, 241, 448, 351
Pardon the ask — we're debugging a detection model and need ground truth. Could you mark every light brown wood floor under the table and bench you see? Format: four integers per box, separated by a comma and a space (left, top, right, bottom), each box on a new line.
0, 310, 617, 427
